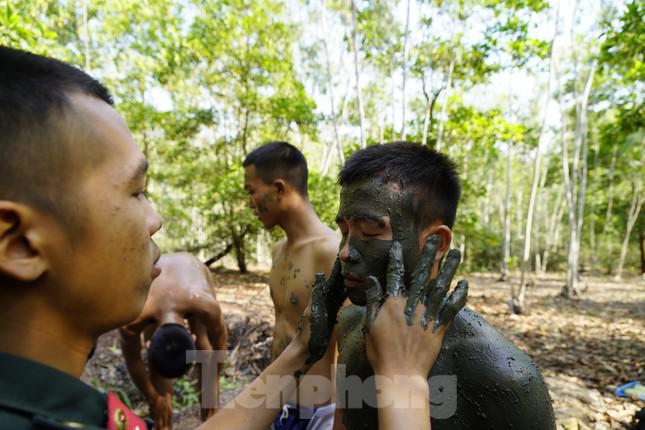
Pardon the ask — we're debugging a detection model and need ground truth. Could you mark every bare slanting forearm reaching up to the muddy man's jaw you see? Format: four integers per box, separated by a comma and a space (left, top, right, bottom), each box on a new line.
199, 342, 307, 430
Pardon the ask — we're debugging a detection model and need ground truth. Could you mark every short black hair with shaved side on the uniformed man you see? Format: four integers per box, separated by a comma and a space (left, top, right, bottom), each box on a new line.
0, 46, 113, 228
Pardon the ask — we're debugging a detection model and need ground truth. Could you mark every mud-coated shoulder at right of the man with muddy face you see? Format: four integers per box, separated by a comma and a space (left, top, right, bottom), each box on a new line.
431, 308, 555, 429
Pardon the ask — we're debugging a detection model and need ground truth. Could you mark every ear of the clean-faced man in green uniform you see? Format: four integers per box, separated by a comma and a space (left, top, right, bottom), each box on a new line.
0, 200, 48, 282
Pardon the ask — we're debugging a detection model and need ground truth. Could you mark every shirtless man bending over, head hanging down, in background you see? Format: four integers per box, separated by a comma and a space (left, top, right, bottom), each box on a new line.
119, 253, 226, 429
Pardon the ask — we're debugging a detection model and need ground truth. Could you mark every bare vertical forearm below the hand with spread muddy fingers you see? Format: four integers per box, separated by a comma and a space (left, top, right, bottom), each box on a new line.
375, 373, 430, 430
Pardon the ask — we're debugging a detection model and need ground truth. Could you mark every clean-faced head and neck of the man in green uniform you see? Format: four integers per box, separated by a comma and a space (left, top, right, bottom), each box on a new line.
0, 47, 161, 374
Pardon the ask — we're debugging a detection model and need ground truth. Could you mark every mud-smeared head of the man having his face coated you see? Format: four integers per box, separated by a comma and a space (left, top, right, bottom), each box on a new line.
336, 142, 461, 305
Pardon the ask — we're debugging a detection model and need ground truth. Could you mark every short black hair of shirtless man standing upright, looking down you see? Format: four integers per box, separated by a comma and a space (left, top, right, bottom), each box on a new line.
243, 142, 309, 197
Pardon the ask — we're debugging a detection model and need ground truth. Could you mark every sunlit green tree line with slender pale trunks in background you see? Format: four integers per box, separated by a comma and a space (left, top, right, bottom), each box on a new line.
0, 0, 645, 312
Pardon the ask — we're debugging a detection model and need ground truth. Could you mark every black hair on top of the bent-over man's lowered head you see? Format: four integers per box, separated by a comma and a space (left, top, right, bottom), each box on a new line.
148, 323, 195, 379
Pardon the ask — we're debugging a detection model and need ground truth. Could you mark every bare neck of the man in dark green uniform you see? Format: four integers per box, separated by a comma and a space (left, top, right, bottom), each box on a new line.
0, 296, 93, 378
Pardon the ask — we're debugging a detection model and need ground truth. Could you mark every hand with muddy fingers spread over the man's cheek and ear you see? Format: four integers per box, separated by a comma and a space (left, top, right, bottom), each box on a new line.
363, 236, 468, 375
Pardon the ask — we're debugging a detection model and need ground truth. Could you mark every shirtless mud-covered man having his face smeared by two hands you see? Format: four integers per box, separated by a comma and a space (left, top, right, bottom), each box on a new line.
328, 143, 555, 430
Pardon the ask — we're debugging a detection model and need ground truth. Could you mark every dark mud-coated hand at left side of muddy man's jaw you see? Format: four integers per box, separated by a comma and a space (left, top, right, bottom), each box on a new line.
307, 258, 347, 364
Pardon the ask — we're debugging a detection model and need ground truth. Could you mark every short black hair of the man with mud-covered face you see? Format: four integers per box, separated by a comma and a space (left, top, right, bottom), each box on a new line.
338, 142, 461, 228
